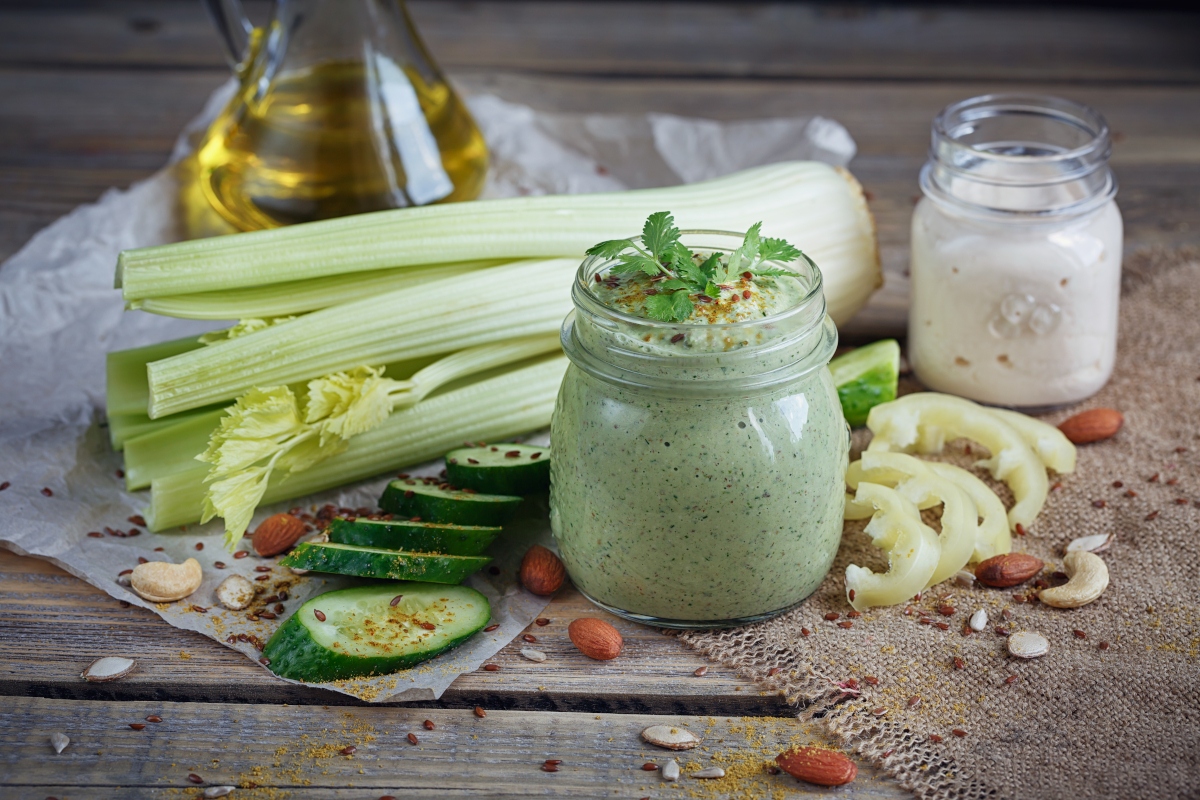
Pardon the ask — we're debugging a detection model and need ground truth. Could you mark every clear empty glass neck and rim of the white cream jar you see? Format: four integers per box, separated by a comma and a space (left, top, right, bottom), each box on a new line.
920, 94, 1117, 221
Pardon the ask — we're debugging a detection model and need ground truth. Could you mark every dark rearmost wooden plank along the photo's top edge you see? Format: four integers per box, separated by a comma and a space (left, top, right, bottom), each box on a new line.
0, 0, 1200, 82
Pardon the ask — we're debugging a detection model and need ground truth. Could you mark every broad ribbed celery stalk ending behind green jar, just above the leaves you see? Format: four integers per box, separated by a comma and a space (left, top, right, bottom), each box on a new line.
146, 259, 577, 419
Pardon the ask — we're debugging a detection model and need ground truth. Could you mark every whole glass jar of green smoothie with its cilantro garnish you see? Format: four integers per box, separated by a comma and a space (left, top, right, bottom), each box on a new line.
550, 212, 850, 627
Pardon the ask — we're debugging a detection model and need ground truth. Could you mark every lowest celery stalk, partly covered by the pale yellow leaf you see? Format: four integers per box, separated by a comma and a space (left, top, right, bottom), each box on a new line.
144, 356, 568, 530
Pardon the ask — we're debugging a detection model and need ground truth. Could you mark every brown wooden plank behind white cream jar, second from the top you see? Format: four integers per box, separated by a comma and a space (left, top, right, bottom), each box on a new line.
0, 70, 1200, 342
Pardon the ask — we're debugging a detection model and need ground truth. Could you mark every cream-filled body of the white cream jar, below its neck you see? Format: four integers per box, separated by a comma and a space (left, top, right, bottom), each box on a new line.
908, 198, 1122, 409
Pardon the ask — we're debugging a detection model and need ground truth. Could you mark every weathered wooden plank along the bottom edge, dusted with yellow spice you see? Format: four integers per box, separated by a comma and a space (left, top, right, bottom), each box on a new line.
0, 698, 911, 800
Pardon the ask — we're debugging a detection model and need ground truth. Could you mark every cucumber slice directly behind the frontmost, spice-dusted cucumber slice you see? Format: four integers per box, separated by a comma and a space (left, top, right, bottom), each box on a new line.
280, 542, 492, 583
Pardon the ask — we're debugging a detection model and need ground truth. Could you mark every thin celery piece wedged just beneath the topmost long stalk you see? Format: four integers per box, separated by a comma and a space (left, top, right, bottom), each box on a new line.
128, 260, 504, 319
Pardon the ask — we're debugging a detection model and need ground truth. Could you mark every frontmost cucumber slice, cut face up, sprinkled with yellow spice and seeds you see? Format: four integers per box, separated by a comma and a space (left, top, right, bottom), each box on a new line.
263, 582, 492, 682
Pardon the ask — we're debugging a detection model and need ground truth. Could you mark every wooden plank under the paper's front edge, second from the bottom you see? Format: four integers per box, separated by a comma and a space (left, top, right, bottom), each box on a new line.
0, 548, 787, 715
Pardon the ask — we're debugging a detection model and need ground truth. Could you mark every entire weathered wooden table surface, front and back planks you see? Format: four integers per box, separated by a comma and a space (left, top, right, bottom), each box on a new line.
0, 0, 1200, 799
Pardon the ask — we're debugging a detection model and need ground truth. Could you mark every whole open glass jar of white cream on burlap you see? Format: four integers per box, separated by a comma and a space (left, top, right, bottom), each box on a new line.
908, 95, 1123, 410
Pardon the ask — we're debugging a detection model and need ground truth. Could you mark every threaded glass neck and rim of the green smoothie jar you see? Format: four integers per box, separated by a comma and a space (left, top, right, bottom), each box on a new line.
562, 230, 838, 396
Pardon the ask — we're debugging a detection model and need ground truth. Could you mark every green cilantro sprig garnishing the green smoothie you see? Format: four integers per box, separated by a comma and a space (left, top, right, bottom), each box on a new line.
588, 211, 816, 323
